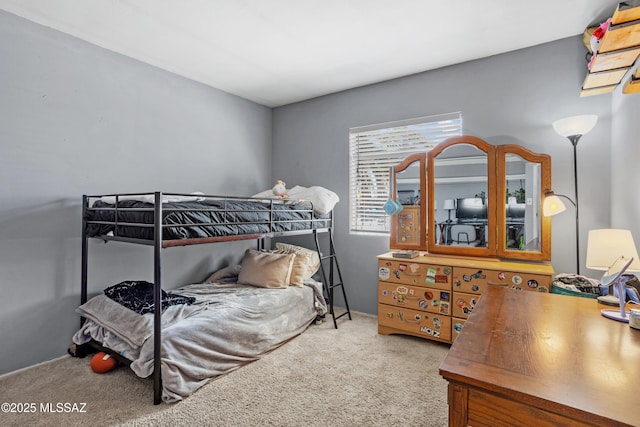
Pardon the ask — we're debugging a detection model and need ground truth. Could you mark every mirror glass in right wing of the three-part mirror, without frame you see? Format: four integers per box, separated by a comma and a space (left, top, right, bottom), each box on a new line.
504, 153, 542, 252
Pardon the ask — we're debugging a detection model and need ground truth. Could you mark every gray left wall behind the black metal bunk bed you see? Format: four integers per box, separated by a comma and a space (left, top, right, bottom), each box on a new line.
0, 12, 271, 373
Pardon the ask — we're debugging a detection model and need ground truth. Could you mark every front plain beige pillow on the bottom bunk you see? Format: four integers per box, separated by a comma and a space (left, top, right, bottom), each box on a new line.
238, 249, 296, 288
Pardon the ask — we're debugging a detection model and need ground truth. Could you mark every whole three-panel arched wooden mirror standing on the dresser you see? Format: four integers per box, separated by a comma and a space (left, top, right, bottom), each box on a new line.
391, 136, 551, 260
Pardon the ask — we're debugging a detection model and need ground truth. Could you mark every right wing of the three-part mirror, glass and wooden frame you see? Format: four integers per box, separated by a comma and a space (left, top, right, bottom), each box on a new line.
497, 145, 551, 260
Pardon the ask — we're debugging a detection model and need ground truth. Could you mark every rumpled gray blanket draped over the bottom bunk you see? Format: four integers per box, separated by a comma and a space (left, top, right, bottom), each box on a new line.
73, 279, 326, 402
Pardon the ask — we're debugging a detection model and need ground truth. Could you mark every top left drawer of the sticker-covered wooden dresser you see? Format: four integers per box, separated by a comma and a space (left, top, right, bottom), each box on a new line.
378, 259, 452, 291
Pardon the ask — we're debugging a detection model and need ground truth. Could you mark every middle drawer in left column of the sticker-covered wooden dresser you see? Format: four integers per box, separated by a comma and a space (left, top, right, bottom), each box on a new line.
378, 282, 451, 315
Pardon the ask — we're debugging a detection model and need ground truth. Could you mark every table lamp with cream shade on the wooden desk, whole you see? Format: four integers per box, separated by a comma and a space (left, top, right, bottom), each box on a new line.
586, 229, 640, 322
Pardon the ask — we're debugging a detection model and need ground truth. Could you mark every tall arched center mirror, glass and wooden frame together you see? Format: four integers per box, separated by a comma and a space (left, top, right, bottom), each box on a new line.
428, 137, 496, 256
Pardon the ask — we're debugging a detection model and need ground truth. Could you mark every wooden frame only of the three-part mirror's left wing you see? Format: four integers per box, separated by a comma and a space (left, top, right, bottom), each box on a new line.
389, 153, 427, 250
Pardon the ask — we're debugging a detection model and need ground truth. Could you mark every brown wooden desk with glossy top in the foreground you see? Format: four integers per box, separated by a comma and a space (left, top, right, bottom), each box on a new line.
440, 287, 640, 427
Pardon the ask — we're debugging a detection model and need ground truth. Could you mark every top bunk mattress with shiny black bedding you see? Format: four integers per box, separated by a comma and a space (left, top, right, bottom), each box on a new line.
84, 196, 331, 240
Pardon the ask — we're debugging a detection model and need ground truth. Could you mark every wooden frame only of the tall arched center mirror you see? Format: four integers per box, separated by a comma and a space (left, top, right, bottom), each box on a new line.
425, 135, 498, 257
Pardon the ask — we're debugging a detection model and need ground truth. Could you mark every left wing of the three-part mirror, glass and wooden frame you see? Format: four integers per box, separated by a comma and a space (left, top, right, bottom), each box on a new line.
389, 153, 427, 250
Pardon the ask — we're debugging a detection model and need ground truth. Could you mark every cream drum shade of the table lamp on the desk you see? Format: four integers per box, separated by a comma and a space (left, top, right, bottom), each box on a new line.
586, 228, 640, 271
